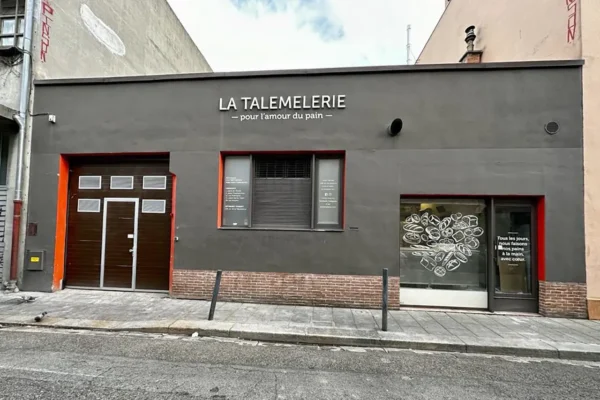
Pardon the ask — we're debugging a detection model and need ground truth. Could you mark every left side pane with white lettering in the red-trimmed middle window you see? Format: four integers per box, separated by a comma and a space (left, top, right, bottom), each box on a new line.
223, 157, 250, 227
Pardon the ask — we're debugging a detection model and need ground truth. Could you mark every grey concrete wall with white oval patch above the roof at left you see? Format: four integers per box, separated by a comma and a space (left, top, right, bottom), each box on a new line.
33, 0, 211, 79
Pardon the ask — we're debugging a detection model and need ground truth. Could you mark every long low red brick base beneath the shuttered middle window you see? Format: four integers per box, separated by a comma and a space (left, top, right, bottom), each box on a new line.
171, 269, 400, 309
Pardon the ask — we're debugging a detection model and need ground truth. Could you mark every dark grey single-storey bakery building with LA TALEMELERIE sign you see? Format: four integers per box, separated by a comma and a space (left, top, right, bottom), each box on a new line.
23, 61, 585, 317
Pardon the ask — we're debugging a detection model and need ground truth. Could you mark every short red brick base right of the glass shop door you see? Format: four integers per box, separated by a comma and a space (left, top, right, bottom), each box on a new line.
540, 281, 588, 318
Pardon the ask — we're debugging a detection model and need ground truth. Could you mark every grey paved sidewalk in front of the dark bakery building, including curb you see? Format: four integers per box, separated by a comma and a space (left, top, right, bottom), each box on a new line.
0, 289, 600, 361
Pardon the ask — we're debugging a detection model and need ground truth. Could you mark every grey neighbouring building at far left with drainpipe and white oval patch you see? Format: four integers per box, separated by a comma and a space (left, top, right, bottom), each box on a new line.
0, 0, 211, 288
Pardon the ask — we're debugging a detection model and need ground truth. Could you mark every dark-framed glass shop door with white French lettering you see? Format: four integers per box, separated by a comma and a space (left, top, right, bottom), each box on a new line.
489, 199, 538, 312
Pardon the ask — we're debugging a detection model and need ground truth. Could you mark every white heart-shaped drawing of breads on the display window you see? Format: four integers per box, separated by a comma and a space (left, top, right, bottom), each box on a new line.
402, 212, 484, 277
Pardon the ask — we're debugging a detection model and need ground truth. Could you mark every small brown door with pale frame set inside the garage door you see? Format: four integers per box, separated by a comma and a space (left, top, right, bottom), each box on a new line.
100, 198, 139, 289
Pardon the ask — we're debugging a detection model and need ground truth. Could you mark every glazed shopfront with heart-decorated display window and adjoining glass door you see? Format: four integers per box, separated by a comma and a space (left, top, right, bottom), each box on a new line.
400, 198, 538, 312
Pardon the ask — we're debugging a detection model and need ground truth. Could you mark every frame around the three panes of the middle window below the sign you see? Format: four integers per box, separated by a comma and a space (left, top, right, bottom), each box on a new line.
218, 151, 346, 232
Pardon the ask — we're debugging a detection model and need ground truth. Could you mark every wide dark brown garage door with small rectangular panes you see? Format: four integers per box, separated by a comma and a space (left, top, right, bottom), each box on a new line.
64, 156, 173, 291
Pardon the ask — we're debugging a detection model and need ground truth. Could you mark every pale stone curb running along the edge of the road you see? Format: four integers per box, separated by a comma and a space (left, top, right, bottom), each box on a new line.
0, 317, 600, 362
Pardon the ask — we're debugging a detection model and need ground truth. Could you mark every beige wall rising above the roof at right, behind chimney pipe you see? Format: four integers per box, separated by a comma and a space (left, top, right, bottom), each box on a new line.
417, 0, 580, 64
